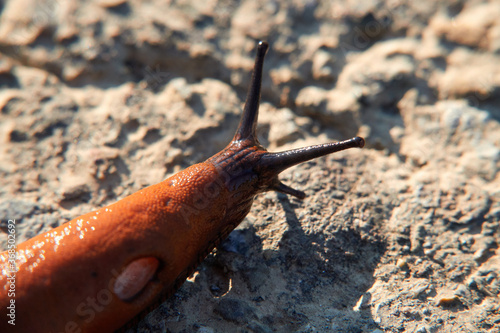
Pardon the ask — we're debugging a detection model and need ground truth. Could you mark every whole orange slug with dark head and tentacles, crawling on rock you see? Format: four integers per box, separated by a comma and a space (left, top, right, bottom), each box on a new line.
0, 42, 364, 333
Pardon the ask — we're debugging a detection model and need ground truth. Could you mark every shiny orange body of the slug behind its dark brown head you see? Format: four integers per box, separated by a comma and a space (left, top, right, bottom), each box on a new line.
0, 163, 228, 332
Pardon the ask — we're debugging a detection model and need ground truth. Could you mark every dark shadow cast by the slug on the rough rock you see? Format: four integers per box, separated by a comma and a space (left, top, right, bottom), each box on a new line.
137, 194, 385, 332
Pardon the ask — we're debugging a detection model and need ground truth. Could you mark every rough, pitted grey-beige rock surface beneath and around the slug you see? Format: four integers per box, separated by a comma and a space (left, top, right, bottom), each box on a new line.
0, 0, 500, 333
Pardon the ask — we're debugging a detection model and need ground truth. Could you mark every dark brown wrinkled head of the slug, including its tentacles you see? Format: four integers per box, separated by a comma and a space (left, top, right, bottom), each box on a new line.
207, 41, 365, 200
